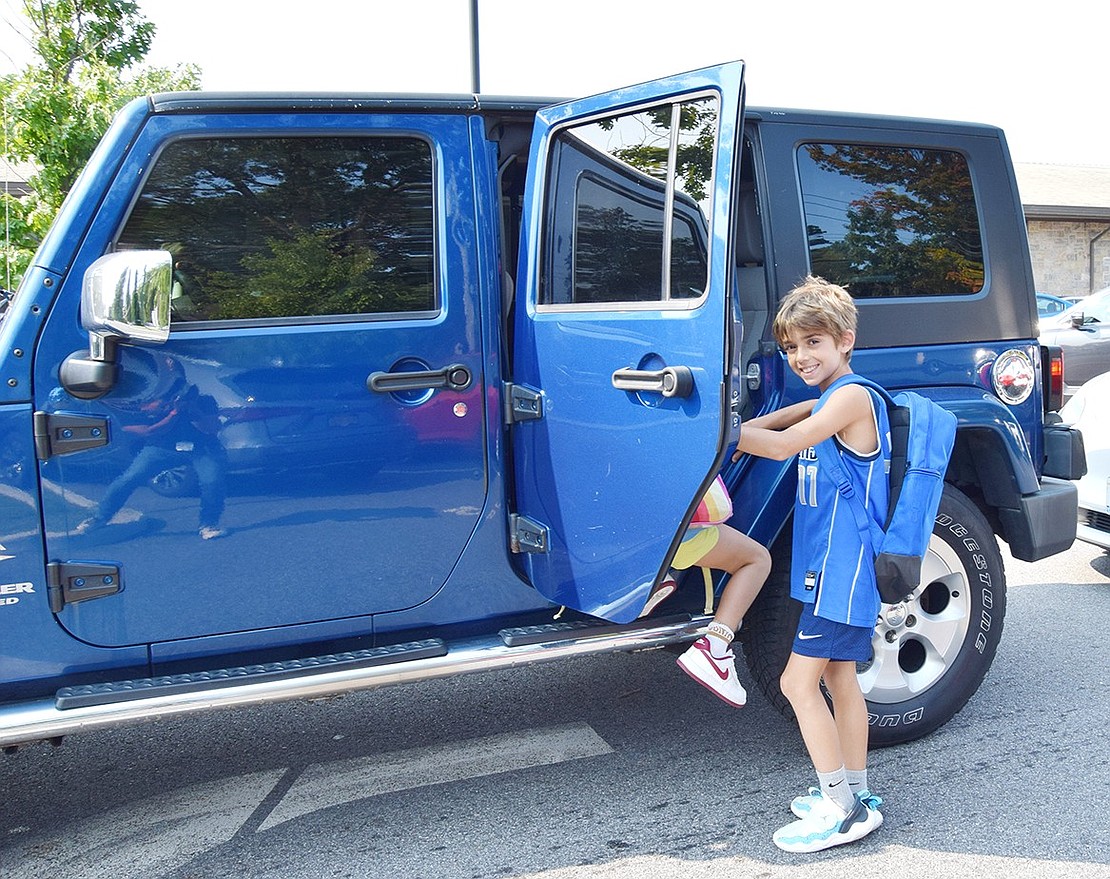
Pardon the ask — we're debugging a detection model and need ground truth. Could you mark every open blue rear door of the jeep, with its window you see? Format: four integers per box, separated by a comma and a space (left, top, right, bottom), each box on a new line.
508, 62, 744, 623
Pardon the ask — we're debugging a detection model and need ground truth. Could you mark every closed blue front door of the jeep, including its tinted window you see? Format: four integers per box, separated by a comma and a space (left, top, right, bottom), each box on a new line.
36, 113, 487, 645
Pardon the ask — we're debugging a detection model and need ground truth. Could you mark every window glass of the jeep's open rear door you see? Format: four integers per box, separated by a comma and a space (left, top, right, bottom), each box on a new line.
541, 99, 717, 304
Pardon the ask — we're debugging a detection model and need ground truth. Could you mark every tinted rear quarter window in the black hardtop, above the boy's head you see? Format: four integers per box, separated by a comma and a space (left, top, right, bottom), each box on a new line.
798, 143, 983, 299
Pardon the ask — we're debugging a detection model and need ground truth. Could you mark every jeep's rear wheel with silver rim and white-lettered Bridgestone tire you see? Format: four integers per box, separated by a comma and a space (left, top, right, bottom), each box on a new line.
741, 486, 1006, 747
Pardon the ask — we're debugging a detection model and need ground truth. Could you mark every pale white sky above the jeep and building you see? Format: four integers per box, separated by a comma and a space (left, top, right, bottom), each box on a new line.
0, 0, 1110, 166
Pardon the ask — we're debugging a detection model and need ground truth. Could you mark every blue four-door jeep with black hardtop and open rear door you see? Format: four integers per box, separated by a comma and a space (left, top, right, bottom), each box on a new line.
0, 63, 1082, 747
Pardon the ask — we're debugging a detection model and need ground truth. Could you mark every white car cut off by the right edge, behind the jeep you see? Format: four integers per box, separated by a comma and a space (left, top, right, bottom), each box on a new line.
1060, 365, 1110, 549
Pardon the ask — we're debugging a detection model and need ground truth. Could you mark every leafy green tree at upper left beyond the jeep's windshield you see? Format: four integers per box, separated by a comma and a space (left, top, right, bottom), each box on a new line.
0, 0, 200, 287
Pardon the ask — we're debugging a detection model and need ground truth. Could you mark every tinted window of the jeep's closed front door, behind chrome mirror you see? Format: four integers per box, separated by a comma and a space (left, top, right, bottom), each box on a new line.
117, 137, 436, 322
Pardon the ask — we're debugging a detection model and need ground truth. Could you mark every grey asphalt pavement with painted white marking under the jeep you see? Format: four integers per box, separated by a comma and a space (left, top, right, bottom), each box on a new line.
0, 544, 1110, 879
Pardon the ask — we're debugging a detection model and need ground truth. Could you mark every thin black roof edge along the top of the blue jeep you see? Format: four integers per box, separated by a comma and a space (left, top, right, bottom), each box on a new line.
150, 91, 999, 135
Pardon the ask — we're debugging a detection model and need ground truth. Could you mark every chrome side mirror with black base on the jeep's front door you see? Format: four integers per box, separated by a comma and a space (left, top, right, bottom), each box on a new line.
59, 251, 173, 400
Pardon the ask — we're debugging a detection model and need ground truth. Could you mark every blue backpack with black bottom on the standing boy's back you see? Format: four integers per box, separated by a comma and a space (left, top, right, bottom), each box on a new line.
817, 373, 956, 604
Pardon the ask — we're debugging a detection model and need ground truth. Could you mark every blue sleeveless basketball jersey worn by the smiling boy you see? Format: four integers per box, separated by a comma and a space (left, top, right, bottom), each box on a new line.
790, 383, 890, 627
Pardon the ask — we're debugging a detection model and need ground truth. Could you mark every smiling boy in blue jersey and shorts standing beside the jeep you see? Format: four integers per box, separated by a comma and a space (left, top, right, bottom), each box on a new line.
735, 276, 890, 851
